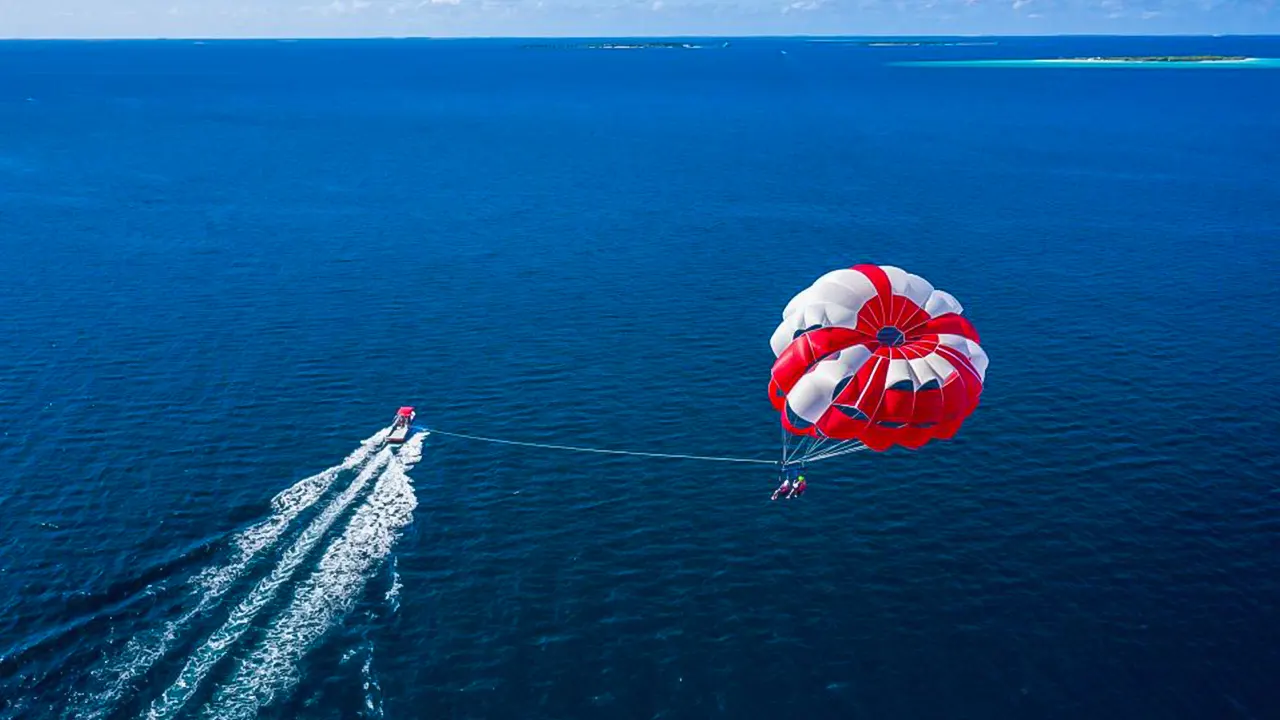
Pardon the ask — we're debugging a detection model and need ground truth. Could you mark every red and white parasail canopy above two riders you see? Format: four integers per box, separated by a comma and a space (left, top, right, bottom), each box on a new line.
769, 265, 987, 461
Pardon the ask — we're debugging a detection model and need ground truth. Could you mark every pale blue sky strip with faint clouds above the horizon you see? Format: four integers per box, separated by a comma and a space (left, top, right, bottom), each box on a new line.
0, 0, 1280, 37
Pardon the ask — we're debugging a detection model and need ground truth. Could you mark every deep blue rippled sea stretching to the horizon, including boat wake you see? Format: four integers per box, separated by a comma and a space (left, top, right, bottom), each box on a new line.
0, 37, 1280, 720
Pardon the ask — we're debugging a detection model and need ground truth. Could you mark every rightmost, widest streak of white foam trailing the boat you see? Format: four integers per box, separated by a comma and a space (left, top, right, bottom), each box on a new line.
205, 434, 425, 719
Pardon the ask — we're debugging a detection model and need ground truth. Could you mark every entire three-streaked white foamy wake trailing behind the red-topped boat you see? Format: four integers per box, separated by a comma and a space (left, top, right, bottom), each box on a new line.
68, 428, 426, 719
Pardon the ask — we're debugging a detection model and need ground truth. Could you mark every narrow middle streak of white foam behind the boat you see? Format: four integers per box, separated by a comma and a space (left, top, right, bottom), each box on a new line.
147, 447, 392, 719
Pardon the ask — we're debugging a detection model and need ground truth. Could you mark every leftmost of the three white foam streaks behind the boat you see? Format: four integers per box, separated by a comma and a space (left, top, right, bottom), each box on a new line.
72, 428, 390, 719
